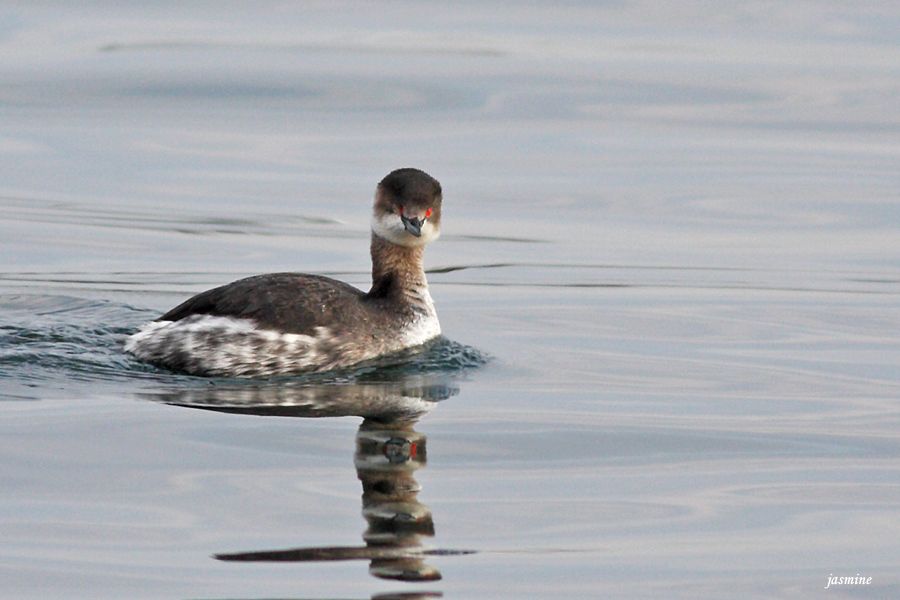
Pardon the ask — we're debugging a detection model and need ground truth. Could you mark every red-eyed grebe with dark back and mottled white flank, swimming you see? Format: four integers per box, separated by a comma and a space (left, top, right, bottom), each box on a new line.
125, 168, 442, 377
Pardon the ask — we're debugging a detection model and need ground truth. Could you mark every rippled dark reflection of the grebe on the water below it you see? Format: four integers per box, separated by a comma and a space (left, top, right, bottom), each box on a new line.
139, 375, 470, 581
